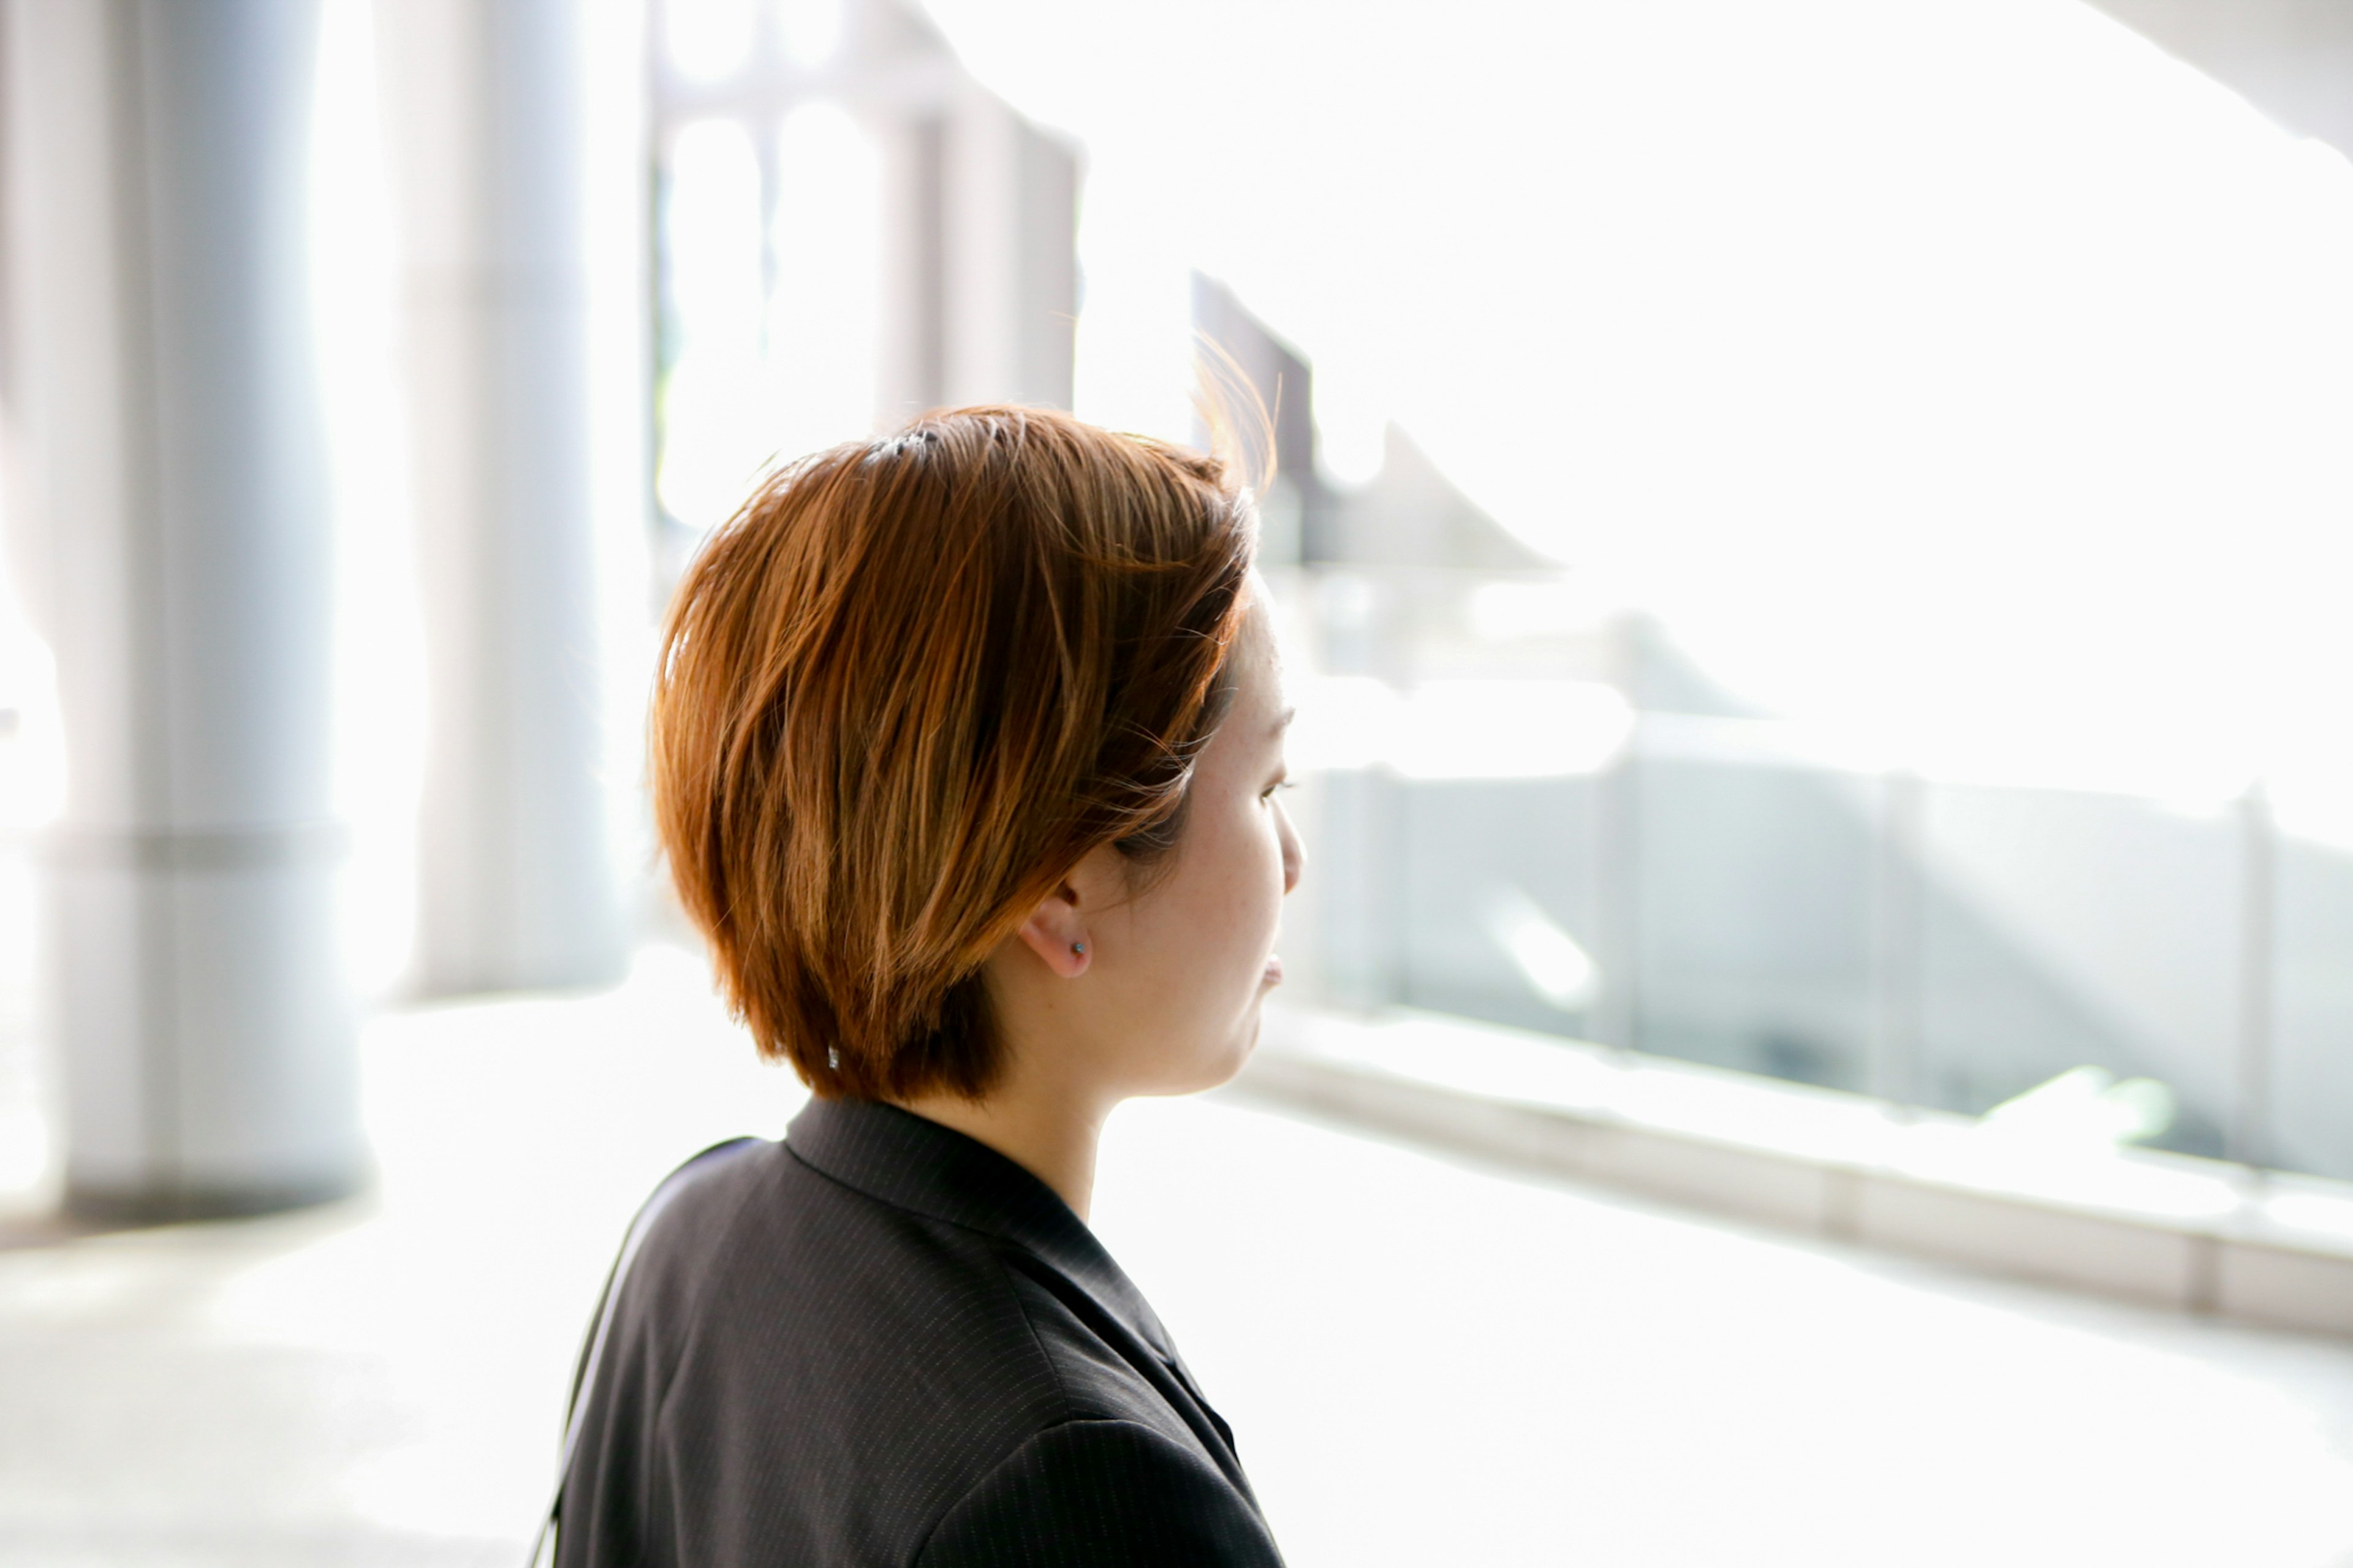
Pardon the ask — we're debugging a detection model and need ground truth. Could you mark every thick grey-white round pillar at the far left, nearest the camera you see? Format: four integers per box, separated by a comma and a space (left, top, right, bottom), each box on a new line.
5, 0, 362, 1215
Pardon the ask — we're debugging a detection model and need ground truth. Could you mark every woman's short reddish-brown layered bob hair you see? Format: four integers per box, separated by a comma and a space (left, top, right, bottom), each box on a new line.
650, 407, 1254, 1099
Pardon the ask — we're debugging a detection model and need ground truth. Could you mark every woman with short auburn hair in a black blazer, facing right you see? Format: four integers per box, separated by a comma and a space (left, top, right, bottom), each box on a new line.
558, 407, 1299, 1568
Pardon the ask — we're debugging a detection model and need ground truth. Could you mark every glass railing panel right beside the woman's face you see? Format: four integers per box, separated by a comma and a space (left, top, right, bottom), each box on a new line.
1280, 570, 1631, 1036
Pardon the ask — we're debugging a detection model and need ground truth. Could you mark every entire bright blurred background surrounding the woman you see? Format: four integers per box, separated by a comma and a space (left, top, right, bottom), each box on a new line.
0, 0, 2353, 1568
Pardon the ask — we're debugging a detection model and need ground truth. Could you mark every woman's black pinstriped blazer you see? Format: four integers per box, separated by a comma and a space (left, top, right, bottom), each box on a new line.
555, 1099, 1280, 1568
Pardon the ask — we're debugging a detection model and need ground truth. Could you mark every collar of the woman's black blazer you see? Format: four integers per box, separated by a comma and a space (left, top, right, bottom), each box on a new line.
784, 1099, 1181, 1366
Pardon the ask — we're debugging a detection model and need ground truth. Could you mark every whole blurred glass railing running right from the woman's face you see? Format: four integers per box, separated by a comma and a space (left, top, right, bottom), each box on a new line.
1275, 567, 2353, 1177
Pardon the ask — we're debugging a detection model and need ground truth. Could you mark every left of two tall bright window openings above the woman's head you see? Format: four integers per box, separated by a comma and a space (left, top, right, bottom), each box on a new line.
656, 120, 776, 528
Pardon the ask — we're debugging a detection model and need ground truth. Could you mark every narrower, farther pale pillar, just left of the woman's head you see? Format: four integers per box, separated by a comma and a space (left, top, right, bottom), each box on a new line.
376, 0, 628, 993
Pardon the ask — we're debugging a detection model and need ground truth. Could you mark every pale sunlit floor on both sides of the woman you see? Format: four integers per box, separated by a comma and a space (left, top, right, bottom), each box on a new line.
0, 949, 2353, 1568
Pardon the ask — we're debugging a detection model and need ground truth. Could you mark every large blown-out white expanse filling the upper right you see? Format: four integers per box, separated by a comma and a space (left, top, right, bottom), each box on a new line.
930, 0, 2353, 793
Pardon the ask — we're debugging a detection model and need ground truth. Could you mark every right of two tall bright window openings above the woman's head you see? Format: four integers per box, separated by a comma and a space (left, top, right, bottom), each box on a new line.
770, 104, 882, 455
